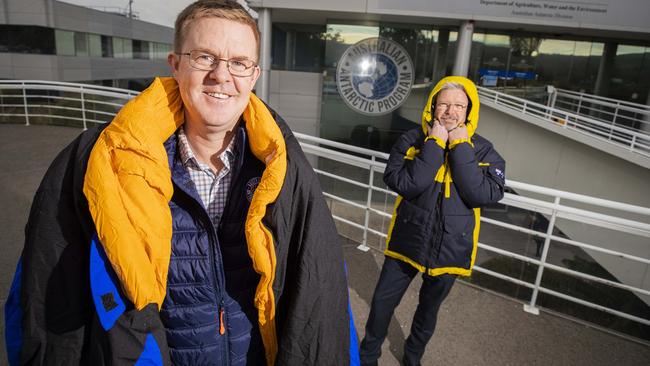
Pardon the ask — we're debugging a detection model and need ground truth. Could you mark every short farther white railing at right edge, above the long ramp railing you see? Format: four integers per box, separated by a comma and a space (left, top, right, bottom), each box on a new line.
549, 89, 650, 133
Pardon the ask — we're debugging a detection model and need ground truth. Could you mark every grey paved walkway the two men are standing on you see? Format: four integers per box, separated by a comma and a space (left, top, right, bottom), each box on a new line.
0, 125, 650, 366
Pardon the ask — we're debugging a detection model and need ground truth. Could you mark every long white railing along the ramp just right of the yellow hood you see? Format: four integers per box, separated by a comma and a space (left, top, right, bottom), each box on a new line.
478, 87, 650, 157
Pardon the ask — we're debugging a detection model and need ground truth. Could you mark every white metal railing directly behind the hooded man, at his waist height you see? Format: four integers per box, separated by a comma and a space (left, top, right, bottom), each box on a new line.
295, 133, 650, 338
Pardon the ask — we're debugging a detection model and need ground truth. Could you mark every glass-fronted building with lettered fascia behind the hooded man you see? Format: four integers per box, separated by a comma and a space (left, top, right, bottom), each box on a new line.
248, 0, 650, 151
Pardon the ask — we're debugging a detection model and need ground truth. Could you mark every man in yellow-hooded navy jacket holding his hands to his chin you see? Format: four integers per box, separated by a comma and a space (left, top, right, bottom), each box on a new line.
360, 76, 505, 366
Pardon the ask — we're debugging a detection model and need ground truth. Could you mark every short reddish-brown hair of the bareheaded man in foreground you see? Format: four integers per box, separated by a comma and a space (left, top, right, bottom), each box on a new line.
174, 0, 260, 61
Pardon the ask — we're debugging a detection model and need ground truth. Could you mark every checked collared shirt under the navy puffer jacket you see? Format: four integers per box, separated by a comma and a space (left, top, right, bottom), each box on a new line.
178, 126, 236, 227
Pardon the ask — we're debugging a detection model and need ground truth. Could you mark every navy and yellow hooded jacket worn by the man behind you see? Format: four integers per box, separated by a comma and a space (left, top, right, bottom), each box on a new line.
384, 76, 505, 276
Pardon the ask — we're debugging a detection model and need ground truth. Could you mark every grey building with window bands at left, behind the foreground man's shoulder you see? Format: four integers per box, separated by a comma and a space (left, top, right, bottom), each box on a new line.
0, 0, 174, 90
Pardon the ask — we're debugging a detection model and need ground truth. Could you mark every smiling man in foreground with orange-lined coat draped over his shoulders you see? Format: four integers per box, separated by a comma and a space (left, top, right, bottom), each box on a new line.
6, 0, 356, 365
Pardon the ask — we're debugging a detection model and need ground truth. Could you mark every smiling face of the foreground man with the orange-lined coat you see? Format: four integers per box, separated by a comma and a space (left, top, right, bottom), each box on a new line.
168, 17, 260, 131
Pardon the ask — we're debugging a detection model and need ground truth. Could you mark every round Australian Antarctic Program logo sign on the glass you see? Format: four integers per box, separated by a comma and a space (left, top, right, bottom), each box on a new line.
336, 38, 413, 116
